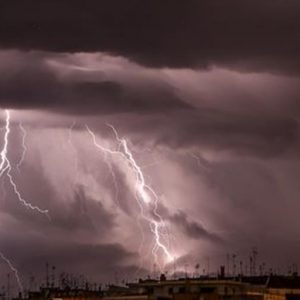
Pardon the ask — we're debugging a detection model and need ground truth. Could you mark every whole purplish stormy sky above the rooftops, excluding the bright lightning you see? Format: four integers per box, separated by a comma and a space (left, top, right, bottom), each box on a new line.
0, 0, 300, 290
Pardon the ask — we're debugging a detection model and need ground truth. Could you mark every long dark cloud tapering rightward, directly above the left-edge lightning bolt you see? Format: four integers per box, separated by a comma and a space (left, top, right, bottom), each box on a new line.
0, 52, 191, 115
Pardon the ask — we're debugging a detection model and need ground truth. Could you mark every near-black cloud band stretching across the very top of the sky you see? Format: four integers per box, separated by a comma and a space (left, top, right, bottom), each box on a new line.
0, 0, 300, 73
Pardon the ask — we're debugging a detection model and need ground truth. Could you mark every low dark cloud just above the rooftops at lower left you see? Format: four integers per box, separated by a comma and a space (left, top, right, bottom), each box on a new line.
1, 235, 137, 283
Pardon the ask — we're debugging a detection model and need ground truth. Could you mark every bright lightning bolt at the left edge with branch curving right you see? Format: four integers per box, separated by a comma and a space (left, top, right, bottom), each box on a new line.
0, 109, 49, 218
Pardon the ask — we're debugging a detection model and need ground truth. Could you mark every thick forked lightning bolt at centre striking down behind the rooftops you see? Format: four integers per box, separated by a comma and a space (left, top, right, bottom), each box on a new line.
86, 124, 175, 263
